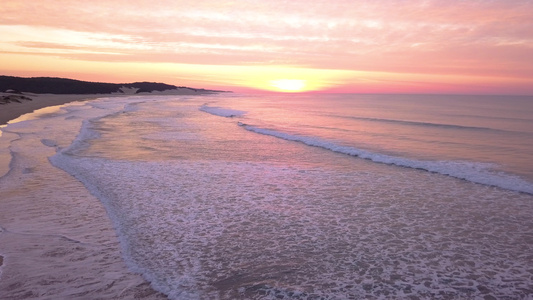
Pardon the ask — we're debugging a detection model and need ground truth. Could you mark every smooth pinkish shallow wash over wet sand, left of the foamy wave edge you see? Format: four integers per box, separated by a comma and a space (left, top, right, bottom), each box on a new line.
0, 100, 167, 299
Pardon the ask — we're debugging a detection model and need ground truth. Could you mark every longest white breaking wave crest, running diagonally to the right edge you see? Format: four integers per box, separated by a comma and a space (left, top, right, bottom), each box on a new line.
238, 122, 533, 195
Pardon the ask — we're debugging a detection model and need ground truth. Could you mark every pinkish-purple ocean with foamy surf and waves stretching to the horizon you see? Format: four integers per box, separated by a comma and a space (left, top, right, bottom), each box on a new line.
0, 93, 533, 299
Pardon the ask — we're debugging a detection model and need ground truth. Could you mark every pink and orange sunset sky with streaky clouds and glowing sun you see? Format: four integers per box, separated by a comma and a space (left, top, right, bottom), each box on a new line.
0, 0, 533, 95
